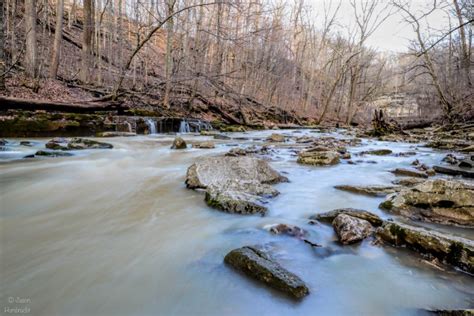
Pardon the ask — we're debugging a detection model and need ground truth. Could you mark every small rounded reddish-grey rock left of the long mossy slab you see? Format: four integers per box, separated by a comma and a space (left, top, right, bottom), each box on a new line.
332, 214, 372, 245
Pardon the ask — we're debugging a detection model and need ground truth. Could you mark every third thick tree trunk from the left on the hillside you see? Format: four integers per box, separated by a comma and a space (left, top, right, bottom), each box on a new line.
80, 0, 93, 83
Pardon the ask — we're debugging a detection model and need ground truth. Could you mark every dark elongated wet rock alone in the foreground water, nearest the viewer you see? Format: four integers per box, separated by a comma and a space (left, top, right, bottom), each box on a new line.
224, 246, 309, 299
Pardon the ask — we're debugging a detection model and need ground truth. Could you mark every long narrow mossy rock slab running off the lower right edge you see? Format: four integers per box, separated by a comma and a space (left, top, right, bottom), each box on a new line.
376, 222, 474, 274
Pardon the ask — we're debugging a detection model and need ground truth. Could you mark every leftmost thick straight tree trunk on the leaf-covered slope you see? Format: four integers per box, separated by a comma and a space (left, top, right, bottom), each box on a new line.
25, 0, 38, 78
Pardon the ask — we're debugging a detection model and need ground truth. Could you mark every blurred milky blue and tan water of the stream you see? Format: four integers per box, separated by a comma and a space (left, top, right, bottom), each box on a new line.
0, 131, 474, 316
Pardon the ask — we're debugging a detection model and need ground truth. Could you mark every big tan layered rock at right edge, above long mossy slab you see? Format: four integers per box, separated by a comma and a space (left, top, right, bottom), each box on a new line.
380, 179, 474, 227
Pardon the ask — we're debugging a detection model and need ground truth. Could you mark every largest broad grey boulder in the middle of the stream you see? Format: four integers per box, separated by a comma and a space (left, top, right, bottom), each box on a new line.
185, 156, 288, 215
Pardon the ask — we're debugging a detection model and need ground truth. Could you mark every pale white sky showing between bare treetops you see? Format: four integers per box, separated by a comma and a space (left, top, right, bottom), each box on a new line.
305, 0, 449, 52
